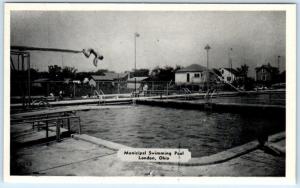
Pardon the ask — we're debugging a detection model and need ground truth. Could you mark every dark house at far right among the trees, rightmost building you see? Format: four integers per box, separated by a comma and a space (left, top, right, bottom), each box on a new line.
255, 63, 279, 83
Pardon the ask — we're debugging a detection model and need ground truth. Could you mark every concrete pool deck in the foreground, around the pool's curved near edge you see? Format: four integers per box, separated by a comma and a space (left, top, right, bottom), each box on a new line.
12, 133, 285, 176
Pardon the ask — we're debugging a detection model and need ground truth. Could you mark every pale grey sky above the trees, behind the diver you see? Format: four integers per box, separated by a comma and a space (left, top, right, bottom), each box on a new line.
10, 11, 286, 77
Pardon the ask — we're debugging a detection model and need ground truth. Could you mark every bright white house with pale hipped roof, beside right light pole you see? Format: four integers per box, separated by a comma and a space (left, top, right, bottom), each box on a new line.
175, 64, 207, 85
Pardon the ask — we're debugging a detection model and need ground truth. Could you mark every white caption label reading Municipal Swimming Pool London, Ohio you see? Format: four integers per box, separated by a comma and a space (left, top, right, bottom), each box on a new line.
118, 148, 191, 163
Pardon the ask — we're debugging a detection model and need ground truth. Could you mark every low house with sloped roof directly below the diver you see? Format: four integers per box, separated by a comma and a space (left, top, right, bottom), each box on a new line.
89, 72, 128, 90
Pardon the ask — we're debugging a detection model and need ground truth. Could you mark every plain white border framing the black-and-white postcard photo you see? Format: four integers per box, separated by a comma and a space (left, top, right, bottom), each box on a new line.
3, 3, 296, 185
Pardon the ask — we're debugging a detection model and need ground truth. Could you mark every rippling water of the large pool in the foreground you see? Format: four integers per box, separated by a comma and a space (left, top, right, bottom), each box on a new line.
77, 105, 285, 157
